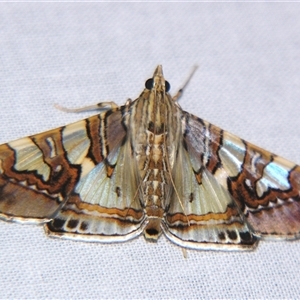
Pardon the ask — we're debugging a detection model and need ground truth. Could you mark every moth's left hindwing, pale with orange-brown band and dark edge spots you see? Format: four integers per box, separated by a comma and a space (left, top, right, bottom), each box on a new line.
45, 123, 145, 242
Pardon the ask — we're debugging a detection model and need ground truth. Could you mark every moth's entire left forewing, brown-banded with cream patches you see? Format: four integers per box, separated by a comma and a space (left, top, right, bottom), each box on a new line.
0, 107, 126, 222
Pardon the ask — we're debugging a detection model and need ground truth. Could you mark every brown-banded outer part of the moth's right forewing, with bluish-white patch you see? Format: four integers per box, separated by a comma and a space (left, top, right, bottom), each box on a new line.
228, 142, 300, 239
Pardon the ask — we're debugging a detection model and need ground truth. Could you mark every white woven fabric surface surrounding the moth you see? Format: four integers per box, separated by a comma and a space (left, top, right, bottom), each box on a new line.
0, 3, 300, 299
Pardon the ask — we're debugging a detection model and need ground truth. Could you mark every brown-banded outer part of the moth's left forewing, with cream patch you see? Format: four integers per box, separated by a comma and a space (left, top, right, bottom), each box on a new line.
0, 129, 80, 222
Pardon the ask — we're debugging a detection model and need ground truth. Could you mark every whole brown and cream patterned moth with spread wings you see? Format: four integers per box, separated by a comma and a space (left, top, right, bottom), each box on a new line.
0, 65, 300, 250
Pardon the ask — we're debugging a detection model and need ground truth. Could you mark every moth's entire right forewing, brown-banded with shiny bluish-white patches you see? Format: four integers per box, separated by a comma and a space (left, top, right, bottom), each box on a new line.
183, 113, 300, 239
